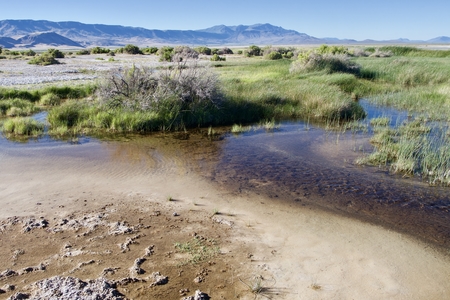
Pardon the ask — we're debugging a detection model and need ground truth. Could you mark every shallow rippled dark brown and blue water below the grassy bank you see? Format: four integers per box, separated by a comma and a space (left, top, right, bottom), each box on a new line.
0, 113, 450, 247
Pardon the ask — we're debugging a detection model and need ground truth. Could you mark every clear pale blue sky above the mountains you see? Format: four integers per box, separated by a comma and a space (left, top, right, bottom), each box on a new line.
0, 0, 450, 40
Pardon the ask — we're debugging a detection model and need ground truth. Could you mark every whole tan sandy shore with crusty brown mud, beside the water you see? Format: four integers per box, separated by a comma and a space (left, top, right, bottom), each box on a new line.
0, 137, 450, 299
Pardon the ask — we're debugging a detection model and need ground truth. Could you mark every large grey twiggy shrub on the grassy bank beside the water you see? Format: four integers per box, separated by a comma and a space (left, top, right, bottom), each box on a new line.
98, 54, 220, 128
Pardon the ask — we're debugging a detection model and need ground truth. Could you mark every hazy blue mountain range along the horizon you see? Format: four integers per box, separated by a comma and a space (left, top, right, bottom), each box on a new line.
0, 20, 450, 48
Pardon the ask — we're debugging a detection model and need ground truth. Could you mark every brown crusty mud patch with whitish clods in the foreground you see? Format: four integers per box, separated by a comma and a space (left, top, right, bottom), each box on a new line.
0, 198, 263, 299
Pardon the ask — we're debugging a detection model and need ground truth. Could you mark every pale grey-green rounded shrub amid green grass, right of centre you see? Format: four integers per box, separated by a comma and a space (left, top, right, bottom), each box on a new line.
290, 51, 361, 75
